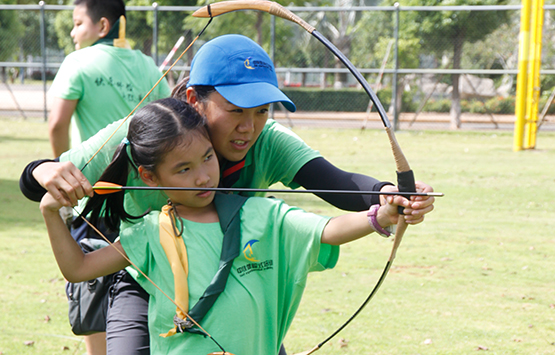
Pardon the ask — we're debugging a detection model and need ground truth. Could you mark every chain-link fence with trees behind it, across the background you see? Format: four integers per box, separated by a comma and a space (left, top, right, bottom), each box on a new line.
0, 0, 555, 129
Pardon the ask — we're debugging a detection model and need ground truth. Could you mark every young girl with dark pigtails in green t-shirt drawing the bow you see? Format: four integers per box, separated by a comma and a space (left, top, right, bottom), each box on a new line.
41, 99, 403, 354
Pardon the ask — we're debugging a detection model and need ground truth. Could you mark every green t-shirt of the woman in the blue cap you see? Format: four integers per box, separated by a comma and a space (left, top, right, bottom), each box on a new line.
60, 119, 320, 215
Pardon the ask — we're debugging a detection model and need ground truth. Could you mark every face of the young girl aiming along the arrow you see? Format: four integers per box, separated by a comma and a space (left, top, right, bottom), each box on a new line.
139, 134, 220, 214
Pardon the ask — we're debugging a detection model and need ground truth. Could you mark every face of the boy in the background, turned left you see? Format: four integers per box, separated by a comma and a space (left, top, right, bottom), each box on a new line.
70, 4, 108, 50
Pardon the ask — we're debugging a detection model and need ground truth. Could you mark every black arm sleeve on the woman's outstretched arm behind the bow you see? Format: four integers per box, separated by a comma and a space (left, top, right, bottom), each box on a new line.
293, 158, 393, 211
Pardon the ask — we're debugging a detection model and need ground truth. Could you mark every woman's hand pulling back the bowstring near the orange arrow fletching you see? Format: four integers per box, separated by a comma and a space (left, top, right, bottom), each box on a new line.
33, 162, 93, 206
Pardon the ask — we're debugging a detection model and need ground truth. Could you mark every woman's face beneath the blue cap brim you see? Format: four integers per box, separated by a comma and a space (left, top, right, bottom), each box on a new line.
196, 92, 270, 161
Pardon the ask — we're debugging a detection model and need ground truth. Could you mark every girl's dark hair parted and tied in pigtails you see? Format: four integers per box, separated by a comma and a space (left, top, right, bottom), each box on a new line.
75, 98, 210, 231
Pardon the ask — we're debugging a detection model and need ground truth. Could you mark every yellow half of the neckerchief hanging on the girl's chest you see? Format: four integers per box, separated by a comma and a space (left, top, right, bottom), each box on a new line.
158, 205, 189, 338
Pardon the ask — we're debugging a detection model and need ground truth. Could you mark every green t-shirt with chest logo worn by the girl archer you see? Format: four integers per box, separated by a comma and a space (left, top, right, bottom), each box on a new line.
120, 196, 339, 355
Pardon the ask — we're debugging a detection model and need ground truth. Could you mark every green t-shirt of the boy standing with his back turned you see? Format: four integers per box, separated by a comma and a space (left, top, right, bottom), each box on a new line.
49, 44, 171, 147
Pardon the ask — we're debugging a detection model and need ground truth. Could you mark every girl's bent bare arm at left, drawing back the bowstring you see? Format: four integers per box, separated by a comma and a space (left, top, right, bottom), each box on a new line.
40, 193, 129, 282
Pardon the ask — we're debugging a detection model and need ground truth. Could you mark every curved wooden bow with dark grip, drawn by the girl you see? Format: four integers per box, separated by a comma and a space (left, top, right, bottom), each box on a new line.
193, 0, 416, 355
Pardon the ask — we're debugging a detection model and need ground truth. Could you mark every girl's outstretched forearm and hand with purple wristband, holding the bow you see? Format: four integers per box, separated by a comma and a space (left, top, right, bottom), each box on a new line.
321, 196, 409, 245
